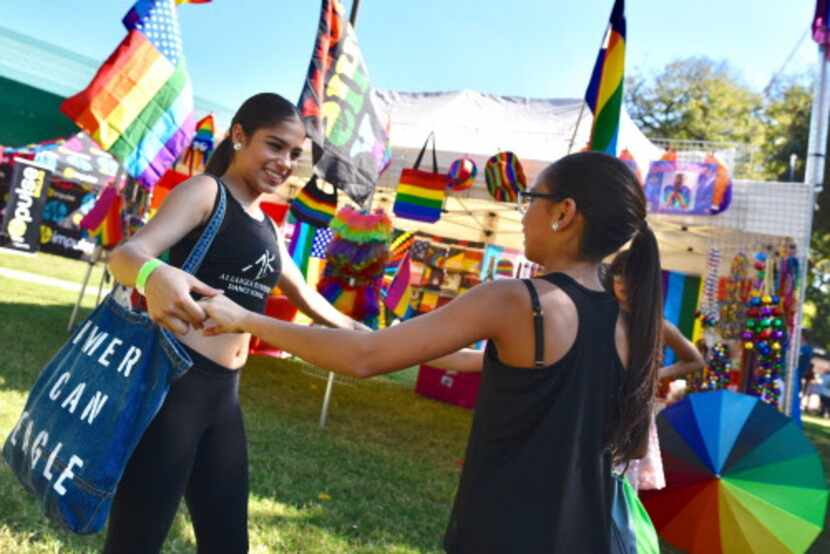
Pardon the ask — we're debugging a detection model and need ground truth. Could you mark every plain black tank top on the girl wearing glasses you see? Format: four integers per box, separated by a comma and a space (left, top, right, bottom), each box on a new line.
444, 273, 623, 554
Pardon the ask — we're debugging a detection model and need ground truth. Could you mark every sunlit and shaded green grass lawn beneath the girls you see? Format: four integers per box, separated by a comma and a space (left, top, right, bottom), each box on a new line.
0, 252, 830, 554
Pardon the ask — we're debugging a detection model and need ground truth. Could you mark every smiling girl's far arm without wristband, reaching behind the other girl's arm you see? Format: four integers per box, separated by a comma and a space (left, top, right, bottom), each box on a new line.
277, 229, 370, 331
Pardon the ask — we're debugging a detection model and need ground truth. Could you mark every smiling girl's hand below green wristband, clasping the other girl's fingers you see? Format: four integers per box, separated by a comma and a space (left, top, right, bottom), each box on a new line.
144, 264, 222, 335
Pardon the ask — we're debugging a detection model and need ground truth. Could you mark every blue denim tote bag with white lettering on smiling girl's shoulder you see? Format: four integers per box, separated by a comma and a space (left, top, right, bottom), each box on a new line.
3, 180, 227, 534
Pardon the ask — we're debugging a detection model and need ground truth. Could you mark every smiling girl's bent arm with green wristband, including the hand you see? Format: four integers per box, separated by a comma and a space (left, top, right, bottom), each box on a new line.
108, 175, 221, 334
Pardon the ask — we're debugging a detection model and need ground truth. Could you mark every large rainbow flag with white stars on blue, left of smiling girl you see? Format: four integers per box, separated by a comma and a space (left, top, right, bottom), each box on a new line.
61, 0, 206, 188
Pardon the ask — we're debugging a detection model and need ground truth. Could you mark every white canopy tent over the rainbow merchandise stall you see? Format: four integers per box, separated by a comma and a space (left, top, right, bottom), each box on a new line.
354, 90, 662, 249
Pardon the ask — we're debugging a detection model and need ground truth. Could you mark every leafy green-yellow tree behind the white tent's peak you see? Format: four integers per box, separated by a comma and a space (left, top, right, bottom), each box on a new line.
625, 58, 763, 145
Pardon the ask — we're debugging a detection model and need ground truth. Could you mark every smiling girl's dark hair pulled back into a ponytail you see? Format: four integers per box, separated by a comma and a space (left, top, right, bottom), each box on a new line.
205, 92, 300, 177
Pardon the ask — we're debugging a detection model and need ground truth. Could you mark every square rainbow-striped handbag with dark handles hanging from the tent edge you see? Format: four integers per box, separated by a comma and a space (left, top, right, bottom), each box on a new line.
392, 133, 449, 223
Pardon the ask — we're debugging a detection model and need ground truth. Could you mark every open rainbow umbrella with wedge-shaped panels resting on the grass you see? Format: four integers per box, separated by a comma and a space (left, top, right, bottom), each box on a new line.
642, 391, 828, 554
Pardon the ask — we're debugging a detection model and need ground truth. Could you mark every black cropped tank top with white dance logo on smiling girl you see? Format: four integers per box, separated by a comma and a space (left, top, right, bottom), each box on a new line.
170, 179, 282, 313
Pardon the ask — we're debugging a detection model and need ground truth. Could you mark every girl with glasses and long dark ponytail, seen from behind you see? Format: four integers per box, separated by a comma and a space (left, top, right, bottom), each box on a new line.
201, 152, 662, 554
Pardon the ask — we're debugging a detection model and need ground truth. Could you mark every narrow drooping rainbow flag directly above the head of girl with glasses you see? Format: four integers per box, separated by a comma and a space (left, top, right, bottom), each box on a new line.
585, 0, 625, 156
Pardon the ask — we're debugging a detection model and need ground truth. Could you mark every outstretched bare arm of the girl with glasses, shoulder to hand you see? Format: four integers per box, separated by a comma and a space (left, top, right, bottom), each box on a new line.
200, 280, 511, 377
